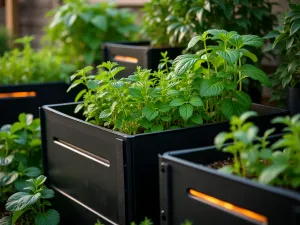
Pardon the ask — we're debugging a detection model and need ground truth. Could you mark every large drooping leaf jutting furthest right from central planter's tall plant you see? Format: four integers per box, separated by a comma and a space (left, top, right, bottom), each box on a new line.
241, 64, 272, 87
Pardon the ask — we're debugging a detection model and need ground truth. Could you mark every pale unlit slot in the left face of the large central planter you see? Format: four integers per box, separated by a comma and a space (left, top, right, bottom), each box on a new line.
53, 138, 110, 167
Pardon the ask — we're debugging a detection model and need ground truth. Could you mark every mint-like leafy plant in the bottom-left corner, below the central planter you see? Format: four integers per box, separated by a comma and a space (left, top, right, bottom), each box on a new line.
0, 175, 60, 225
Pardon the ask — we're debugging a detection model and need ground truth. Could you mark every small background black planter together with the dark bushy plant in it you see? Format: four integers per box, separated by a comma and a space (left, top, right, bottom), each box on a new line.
103, 0, 277, 85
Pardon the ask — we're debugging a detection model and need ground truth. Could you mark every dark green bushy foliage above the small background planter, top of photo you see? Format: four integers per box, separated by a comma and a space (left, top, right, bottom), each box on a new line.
143, 0, 277, 46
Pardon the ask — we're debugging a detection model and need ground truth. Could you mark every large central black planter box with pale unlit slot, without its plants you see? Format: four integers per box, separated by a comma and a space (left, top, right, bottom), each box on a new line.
41, 103, 287, 225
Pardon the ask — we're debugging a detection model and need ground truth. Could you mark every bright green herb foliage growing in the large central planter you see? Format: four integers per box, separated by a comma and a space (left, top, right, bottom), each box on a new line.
69, 30, 270, 134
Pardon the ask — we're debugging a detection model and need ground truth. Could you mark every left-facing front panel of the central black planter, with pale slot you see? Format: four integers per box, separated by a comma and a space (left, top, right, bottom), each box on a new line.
44, 106, 125, 223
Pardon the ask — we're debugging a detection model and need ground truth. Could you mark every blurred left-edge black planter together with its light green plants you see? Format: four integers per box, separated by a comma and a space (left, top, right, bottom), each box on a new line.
0, 37, 75, 125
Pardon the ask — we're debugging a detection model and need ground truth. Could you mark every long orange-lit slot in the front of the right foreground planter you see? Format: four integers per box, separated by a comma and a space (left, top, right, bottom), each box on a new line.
188, 189, 268, 225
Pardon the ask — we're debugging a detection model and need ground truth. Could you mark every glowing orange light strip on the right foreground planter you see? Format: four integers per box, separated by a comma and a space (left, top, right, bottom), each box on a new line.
189, 189, 268, 225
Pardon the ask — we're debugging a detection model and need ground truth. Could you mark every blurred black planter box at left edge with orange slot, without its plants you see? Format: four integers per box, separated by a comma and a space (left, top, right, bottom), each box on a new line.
0, 82, 76, 126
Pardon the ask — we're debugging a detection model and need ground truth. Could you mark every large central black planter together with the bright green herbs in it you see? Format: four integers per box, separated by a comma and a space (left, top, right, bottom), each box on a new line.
41, 30, 286, 224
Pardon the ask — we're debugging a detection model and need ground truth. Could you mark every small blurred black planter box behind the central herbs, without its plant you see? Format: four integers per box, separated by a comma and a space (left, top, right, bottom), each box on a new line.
102, 42, 183, 78
